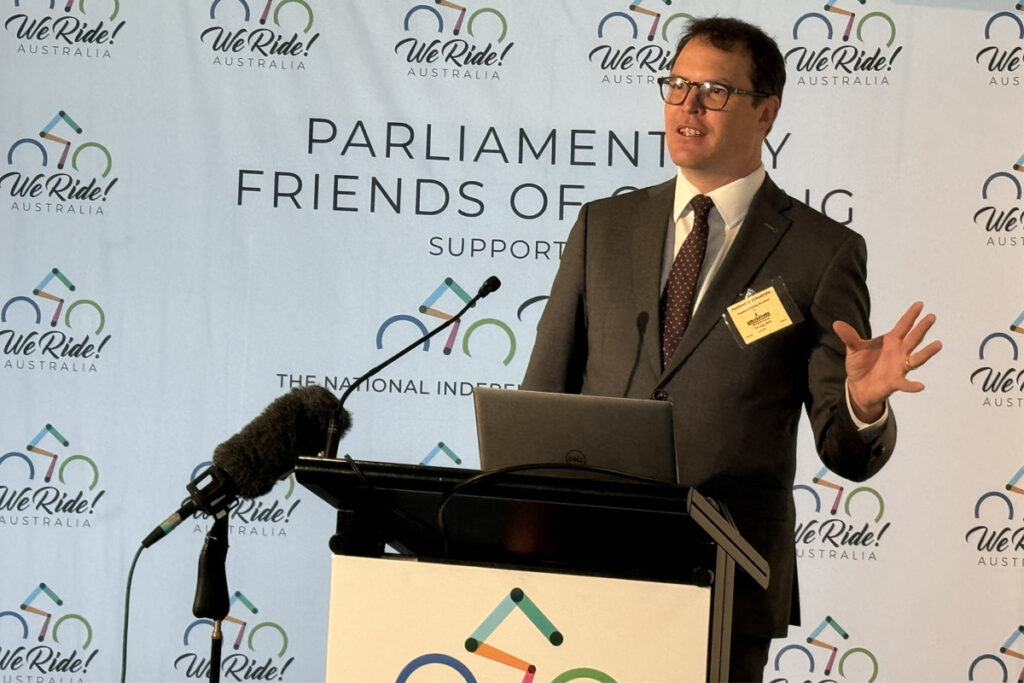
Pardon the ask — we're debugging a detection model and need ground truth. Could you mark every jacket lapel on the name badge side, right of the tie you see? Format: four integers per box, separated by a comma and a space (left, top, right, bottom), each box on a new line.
663, 176, 792, 378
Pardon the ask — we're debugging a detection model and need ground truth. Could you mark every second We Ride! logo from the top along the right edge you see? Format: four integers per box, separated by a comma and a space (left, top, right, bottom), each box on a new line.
973, 155, 1024, 249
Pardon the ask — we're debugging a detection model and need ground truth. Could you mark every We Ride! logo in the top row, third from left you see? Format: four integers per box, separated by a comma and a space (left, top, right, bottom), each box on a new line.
393, 0, 515, 81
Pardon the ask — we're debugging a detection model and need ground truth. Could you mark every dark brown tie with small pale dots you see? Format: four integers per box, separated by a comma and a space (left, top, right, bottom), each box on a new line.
662, 195, 715, 368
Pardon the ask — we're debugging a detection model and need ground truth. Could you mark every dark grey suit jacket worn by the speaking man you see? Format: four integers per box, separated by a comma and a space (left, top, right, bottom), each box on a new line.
522, 177, 896, 637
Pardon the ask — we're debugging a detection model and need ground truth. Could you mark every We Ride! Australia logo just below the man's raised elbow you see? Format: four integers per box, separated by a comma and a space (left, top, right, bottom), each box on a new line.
793, 467, 891, 561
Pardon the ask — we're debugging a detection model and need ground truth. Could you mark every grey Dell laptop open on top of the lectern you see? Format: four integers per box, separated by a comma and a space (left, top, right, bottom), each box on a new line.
473, 387, 677, 483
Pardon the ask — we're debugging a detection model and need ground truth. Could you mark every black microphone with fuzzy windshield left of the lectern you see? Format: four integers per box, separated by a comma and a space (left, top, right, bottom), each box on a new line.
142, 386, 351, 548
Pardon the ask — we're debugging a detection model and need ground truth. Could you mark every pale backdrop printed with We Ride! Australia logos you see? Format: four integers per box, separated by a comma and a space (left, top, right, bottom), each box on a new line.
0, 0, 1024, 682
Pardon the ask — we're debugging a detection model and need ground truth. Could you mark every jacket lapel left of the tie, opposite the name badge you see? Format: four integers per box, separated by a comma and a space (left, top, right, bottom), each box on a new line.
632, 178, 676, 377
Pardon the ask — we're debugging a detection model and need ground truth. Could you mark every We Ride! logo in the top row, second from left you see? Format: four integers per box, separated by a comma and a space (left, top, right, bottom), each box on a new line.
199, 0, 321, 71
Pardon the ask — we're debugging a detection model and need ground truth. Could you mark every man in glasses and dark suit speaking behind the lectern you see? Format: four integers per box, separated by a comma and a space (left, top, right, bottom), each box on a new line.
522, 17, 941, 681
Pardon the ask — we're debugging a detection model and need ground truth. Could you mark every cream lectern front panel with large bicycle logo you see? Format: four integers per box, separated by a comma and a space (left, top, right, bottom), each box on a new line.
327, 555, 711, 683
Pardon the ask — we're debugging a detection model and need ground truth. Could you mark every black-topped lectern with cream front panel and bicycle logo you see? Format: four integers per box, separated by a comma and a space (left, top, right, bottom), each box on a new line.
295, 457, 768, 683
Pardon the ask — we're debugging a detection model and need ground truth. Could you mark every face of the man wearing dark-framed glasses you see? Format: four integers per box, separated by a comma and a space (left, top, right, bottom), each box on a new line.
665, 38, 779, 191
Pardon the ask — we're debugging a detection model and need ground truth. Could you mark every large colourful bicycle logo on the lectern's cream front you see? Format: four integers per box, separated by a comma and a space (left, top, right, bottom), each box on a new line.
395, 588, 615, 683
